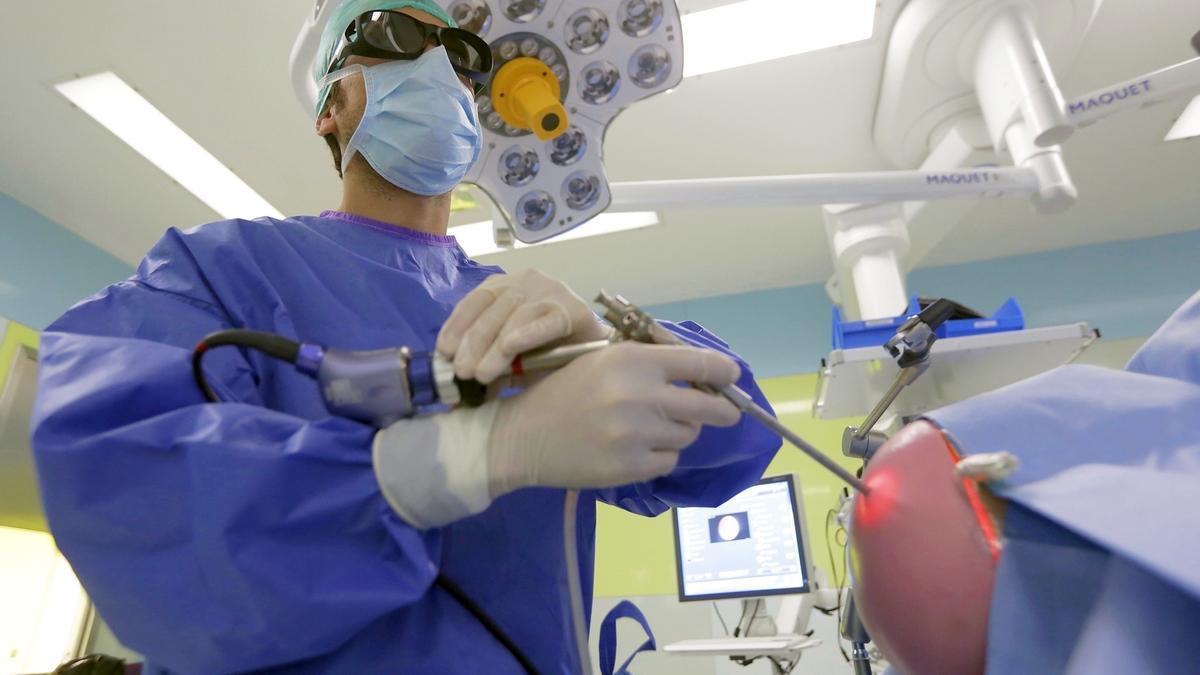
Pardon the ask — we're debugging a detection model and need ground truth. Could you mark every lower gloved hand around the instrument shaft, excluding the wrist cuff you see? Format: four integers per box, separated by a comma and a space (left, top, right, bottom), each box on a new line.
487, 344, 740, 497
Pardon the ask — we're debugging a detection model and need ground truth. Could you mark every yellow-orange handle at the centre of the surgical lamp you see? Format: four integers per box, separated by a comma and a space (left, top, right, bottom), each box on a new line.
492, 58, 570, 141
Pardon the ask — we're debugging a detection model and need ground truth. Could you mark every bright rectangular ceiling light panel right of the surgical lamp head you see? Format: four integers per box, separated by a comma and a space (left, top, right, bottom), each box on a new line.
686, 0, 875, 77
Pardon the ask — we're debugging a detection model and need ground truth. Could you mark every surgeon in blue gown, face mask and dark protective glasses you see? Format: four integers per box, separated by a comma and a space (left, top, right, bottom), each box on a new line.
34, 0, 779, 674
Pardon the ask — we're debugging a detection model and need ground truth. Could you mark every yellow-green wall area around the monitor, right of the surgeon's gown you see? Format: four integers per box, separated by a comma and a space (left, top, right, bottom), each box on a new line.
595, 374, 860, 597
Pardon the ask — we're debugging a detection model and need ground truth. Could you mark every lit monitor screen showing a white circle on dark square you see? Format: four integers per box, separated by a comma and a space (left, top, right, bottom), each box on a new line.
674, 476, 809, 601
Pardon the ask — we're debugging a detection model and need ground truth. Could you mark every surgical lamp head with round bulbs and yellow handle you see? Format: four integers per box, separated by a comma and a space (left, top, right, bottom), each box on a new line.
448, 0, 684, 243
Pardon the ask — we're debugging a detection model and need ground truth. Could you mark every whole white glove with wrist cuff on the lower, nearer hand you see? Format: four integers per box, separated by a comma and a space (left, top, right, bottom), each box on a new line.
373, 344, 740, 528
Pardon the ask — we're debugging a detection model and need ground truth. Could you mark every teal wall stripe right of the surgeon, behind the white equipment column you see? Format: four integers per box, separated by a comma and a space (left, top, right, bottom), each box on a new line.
648, 225, 1200, 377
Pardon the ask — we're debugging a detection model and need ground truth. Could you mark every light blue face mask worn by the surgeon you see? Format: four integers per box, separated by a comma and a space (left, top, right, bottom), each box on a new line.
326, 47, 482, 196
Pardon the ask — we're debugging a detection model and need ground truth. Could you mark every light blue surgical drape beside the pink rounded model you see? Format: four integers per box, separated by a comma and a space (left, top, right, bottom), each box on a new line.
930, 293, 1200, 675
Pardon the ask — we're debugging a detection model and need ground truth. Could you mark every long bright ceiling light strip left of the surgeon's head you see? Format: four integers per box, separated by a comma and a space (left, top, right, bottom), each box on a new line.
54, 72, 283, 219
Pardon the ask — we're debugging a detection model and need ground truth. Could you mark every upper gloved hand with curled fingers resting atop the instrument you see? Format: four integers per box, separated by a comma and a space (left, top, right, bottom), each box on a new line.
437, 269, 610, 384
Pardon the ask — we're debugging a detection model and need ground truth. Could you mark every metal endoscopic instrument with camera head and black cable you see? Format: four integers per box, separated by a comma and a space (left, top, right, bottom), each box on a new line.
192, 291, 868, 495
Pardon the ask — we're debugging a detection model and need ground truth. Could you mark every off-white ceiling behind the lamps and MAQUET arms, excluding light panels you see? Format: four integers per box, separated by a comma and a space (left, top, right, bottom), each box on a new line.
0, 0, 1200, 303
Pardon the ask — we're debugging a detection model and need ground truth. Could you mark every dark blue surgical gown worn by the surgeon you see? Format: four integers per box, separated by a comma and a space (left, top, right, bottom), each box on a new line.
34, 213, 779, 674
